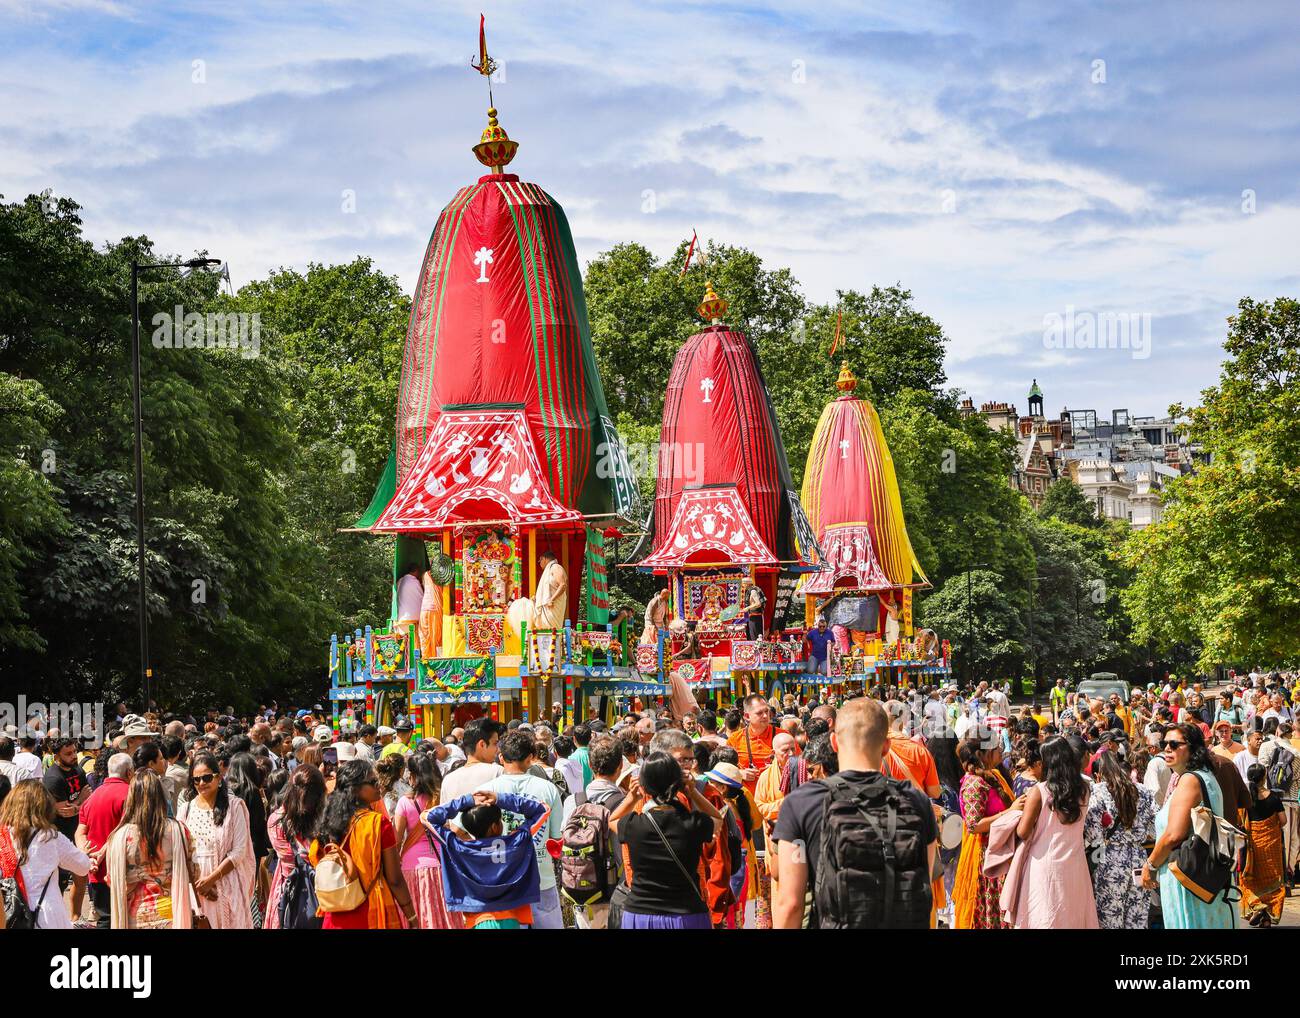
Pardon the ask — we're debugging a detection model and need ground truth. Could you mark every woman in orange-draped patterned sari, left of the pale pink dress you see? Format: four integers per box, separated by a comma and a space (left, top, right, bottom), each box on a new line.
953, 738, 1019, 930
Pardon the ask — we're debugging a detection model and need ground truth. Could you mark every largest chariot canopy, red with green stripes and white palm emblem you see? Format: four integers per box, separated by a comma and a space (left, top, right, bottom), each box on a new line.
369, 109, 641, 533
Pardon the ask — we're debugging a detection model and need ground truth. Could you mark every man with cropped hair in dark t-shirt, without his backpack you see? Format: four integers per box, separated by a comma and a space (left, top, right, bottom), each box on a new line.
772, 697, 939, 930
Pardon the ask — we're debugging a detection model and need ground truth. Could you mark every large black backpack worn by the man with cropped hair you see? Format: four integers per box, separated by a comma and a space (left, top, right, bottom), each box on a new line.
814, 772, 933, 930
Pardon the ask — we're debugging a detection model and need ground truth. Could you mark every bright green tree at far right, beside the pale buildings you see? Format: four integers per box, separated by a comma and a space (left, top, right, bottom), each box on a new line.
1122, 298, 1300, 670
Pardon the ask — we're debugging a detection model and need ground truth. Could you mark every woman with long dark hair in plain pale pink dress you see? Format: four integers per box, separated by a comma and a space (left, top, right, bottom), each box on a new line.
1002, 736, 1097, 930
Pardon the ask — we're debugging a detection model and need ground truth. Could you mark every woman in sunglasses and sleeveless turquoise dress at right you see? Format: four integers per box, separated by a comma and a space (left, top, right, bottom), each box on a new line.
1143, 723, 1236, 930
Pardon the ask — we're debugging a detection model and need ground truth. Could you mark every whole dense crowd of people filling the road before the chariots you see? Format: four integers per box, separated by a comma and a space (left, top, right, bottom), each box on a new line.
0, 673, 1300, 930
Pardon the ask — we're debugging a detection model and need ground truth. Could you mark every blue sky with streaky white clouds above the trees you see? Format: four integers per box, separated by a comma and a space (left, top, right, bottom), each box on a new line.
0, 0, 1300, 415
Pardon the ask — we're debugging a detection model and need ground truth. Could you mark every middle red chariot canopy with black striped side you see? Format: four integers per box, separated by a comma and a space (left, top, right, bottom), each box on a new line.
636, 287, 818, 571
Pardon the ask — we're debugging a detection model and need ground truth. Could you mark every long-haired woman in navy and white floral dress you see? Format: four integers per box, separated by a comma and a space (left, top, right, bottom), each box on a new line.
1083, 753, 1156, 930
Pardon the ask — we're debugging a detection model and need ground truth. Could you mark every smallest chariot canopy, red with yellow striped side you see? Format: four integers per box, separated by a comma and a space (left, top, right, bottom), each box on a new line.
801, 364, 928, 594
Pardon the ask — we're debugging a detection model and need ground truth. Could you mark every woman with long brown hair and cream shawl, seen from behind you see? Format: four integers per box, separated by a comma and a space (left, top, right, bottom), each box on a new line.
107, 770, 196, 930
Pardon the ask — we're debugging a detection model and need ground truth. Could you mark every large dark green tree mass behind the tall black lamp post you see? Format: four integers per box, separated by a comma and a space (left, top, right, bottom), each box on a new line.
0, 196, 308, 702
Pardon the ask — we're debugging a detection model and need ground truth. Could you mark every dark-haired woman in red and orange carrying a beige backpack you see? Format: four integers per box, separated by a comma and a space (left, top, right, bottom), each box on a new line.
311, 754, 419, 930
